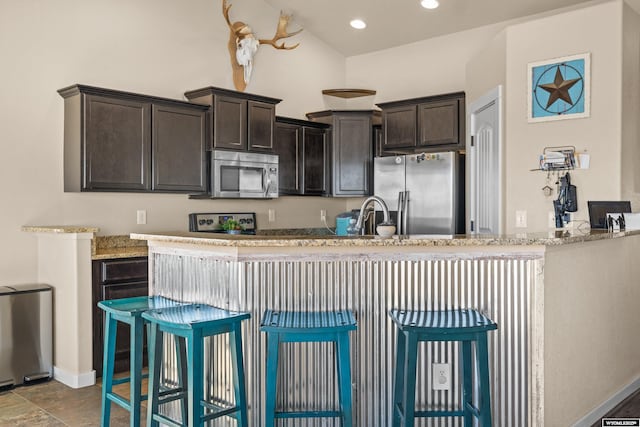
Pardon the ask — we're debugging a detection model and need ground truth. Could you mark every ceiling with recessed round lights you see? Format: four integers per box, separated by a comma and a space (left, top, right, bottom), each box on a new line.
265, 0, 588, 56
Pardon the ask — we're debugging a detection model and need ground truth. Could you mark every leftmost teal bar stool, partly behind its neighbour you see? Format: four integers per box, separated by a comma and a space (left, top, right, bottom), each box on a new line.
98, 296, 188, 427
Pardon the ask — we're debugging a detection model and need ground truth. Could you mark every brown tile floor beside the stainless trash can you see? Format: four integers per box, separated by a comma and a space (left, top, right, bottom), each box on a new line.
0, 381, 146, 427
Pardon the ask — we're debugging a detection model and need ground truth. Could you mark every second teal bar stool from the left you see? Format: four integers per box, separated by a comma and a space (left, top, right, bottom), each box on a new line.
142, 304, 250, 427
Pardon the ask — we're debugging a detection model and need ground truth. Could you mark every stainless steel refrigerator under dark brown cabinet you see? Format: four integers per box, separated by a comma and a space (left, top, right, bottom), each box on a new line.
373, 152, 464, 234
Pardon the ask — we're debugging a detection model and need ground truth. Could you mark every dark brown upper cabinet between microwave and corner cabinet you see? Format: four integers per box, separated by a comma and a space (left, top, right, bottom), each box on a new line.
275, 117, 329, 196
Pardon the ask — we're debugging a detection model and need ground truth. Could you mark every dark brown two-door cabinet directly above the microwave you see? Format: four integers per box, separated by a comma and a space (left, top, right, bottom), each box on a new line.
185, 87, 280, 153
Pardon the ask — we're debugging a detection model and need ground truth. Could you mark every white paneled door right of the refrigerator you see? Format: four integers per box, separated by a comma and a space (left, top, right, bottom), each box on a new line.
467, 86, 504, 234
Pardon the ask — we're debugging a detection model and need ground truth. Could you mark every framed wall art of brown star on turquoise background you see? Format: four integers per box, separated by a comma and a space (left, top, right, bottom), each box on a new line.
527, 53, 591, 123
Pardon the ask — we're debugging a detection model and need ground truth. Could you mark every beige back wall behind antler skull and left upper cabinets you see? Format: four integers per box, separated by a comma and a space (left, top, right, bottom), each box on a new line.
0, 0, 345, 284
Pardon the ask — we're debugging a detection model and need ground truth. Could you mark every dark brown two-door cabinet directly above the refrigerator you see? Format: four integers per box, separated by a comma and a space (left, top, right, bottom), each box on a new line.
378, 92, 465, 155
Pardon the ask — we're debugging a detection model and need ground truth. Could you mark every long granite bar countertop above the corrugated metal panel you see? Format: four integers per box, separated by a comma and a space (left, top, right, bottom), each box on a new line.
131, 230, 640, 248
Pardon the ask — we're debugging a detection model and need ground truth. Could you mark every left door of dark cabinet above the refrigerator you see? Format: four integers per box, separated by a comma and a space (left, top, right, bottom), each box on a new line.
382, 105, 417, 150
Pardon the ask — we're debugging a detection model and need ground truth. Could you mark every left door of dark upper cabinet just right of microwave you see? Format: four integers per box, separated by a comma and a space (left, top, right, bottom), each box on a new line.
274, 123, 302, 194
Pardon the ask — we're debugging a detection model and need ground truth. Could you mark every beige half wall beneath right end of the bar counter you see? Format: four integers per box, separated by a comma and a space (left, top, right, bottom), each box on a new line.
544, 236, 640, 426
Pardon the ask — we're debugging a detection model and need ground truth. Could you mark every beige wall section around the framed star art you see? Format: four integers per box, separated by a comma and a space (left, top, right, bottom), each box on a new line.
505, 1, 623, 233
